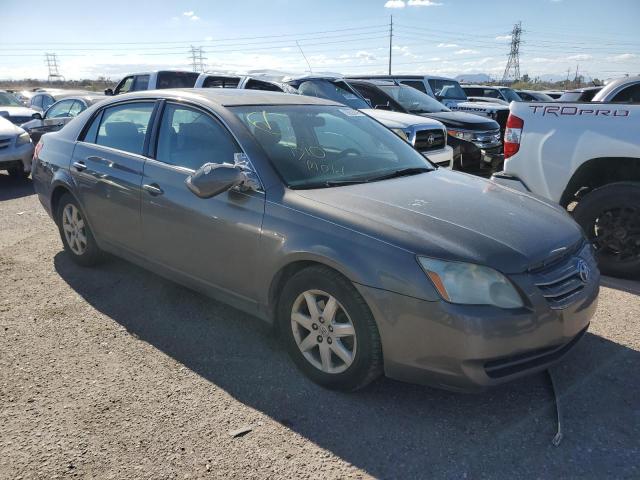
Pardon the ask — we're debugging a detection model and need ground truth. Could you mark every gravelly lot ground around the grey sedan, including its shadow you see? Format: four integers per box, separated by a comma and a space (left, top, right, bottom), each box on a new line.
0, 175, 640, 479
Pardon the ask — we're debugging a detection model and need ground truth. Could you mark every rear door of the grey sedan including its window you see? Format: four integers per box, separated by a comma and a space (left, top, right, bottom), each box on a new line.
70, 100, 156, 253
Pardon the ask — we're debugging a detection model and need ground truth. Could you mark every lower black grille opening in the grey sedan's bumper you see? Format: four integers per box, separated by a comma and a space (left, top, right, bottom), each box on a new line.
484, 328, 587, 378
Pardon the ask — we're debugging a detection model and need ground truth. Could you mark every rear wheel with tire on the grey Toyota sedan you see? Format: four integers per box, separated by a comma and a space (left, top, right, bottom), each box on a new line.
56, 193, 102, 267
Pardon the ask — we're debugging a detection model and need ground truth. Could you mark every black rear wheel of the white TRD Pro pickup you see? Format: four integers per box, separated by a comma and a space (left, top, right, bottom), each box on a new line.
573, 183, 640, 277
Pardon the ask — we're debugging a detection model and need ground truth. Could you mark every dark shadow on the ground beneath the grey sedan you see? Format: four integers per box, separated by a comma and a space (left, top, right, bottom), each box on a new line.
54, 252, 640, 478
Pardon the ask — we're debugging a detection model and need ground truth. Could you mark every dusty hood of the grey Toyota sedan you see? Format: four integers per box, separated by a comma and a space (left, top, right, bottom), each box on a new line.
286, 169, 583, 273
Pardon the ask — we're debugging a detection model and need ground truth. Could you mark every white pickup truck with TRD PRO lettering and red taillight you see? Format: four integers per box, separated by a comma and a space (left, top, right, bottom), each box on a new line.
492, 102, 640, 276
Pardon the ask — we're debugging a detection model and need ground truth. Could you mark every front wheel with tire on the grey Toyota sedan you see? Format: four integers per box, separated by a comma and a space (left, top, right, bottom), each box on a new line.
278, 265, 383, 391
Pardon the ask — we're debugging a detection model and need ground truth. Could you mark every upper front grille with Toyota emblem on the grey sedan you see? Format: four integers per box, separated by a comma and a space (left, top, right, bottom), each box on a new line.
534, 242, 595, 310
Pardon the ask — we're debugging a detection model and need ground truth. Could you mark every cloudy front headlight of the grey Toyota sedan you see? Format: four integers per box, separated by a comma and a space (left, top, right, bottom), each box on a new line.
418, 257, 524, 308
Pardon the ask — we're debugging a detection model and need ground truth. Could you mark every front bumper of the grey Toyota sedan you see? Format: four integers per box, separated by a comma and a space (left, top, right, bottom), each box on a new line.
357, 247, 599, 392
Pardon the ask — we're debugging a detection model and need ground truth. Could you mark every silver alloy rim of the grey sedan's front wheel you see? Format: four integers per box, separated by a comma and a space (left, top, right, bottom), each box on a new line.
291, 290, 357, 374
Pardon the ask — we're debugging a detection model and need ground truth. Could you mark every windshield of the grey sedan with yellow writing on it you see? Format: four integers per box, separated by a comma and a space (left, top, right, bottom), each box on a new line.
230, 105, 434, 188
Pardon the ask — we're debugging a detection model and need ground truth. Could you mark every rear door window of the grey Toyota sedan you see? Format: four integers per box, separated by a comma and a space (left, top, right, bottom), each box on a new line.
94, 102, 154, 155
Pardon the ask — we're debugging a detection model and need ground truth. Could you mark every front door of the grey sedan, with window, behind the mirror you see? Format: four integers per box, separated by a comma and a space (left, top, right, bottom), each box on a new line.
142, 102, 265, 299
